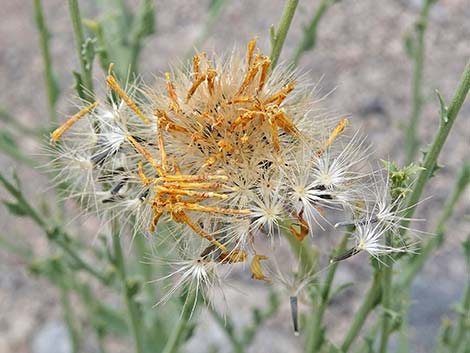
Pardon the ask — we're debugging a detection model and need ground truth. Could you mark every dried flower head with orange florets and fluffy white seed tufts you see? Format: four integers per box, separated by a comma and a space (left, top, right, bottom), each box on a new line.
47, 40, 416, 310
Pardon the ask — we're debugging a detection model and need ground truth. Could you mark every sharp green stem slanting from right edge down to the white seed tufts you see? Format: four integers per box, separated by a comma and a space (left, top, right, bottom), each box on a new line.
401, 60, 470, 233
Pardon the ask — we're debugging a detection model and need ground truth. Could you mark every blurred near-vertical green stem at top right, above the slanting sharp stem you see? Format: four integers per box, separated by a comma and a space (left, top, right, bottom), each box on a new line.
405, 0, 435, 164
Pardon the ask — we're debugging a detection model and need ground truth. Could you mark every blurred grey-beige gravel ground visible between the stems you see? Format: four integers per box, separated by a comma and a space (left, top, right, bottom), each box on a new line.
0, 0, 470, 353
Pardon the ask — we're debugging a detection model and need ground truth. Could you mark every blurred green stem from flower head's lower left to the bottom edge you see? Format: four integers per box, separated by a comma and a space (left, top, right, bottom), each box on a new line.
112, 220, 144, 353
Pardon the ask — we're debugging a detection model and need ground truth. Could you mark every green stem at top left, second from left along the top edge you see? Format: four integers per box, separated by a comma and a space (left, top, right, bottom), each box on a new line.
69, 0, 93, 102
